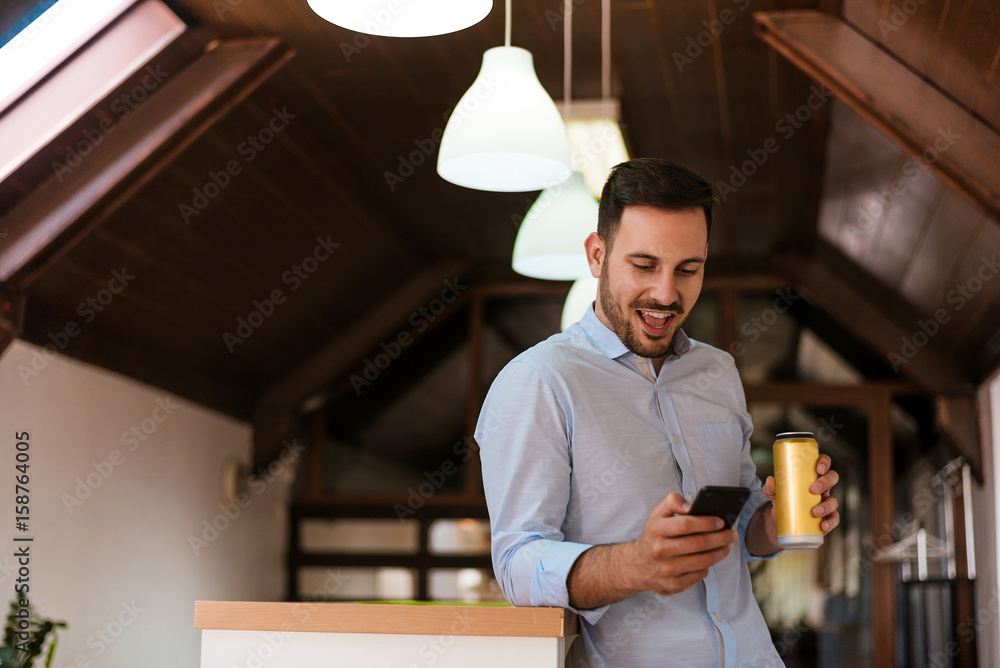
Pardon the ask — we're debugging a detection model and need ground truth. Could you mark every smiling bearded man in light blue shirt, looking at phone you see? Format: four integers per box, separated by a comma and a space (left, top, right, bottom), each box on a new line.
476, 159, 839, 668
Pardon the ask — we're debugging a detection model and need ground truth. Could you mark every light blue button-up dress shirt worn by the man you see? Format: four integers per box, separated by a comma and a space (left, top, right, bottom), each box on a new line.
476, 306, 783, 668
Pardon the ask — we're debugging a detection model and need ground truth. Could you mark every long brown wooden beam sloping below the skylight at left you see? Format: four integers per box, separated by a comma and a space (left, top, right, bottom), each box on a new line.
0, 40, 291, 285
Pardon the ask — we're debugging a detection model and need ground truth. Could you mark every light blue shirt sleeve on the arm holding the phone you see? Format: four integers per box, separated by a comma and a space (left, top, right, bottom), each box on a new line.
476, 360, 606, 621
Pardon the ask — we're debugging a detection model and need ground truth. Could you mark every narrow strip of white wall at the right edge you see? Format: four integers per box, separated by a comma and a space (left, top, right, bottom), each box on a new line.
972, 374, 1000, 666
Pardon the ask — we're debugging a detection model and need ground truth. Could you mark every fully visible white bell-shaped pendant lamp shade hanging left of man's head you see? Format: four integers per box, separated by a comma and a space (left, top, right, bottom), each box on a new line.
438, 46, 571, 192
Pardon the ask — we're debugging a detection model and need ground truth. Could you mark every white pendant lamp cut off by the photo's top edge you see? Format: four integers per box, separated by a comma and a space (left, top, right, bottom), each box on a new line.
308, 0, 493, 37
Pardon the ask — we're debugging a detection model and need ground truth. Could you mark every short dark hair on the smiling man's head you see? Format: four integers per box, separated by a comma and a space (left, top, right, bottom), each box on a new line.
597, 158, 715, 249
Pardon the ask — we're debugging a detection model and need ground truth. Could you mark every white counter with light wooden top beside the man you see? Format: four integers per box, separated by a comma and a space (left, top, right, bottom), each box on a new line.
195, 601, 577, 668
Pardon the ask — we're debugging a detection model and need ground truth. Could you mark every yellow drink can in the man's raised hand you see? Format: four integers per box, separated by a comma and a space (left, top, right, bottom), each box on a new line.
774, 431, 823, 550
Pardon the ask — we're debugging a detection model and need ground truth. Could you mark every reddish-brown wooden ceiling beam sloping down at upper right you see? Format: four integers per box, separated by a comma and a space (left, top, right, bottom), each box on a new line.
755, 12, 1000, 224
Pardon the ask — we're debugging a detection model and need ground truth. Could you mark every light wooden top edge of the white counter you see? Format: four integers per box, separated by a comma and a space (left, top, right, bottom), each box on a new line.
194, 601, 577, 638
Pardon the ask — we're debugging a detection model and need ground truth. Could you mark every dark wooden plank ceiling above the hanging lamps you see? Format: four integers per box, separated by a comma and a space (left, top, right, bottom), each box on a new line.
0, 0, 1000, 464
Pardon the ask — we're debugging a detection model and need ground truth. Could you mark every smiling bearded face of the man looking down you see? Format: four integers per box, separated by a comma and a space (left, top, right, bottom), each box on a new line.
586, 206, 708, 359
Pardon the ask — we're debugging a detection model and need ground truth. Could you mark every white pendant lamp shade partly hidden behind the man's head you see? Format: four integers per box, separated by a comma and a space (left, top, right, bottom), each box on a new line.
511, 172, 597, 281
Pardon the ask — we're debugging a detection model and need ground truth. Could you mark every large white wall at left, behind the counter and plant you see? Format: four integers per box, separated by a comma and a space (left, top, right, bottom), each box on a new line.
0, 341, 294, 668
